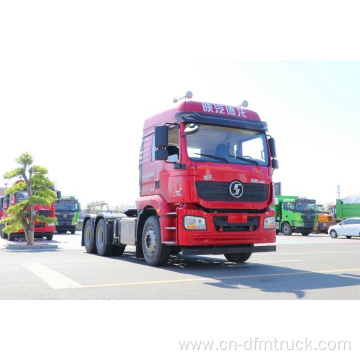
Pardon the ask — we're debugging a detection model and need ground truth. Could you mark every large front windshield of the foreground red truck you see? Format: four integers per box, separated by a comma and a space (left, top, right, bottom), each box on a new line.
185, 124, 269, 166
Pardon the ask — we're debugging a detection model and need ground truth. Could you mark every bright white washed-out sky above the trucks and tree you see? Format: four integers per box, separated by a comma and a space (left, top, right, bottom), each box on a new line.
0, 0, 360, 211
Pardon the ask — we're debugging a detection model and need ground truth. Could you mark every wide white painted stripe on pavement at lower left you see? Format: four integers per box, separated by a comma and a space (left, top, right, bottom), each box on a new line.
22, 263, 82, 290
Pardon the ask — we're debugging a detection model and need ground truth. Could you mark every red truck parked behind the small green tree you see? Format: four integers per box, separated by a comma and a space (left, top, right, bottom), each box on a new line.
0, 183, 56, 240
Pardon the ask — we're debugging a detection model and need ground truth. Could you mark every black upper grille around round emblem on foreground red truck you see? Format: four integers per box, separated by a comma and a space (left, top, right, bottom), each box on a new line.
196, 181, 269, 202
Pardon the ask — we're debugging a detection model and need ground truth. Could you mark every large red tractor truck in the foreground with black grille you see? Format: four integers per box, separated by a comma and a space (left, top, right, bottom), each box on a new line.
82, 95, 278, 266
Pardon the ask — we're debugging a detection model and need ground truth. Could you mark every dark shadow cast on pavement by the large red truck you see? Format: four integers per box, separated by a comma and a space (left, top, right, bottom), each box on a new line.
109, 251, 360, 300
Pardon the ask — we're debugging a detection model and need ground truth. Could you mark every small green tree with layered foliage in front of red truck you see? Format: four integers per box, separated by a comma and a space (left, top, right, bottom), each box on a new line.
1, 153, 57, 245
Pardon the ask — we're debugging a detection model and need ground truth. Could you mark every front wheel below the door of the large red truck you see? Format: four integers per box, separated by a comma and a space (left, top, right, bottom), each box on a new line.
142, 216, 171, 266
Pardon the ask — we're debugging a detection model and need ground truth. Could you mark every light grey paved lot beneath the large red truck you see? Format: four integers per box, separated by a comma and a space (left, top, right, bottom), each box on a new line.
0, 232, 360, 300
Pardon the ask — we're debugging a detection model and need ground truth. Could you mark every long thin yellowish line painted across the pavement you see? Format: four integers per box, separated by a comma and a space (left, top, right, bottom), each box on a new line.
83, 269, 360, 288
